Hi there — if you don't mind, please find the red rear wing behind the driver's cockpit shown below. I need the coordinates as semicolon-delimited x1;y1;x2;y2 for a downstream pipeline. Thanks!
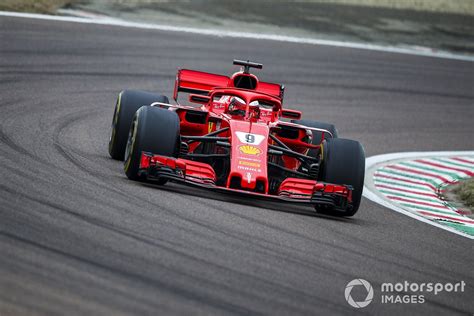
173;69;285;101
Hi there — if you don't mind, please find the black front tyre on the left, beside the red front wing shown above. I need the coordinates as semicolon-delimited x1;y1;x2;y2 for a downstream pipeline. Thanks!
124;106;179;184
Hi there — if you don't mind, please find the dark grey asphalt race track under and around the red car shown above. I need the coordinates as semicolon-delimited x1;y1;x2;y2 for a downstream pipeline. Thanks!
0;17;474;316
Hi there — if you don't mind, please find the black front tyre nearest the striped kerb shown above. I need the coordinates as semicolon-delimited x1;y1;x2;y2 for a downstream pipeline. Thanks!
316;138;365;216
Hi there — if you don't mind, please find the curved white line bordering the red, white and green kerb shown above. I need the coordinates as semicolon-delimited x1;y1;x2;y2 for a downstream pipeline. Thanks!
363;151;474;240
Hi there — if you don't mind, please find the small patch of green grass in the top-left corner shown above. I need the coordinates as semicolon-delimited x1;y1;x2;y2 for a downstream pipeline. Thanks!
0;0;76;14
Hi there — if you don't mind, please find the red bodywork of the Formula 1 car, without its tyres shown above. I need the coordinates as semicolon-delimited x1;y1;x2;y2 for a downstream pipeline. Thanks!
140;66;352;209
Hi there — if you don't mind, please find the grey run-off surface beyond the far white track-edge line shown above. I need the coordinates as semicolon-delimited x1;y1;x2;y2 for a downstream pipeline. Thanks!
73;0;474;55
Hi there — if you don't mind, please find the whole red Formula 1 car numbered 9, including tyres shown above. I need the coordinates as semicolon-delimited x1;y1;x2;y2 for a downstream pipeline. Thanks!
109;60;365;216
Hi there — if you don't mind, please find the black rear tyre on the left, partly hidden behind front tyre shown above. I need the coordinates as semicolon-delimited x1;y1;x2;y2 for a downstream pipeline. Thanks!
109;90;169;160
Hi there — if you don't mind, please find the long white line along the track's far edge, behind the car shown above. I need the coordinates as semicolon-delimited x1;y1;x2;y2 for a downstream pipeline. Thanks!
0;11;474;62
